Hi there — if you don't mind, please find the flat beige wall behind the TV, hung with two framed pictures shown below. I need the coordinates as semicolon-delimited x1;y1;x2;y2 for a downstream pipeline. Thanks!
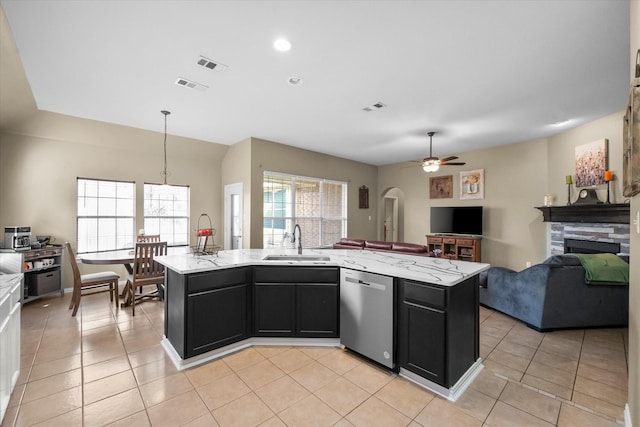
378;140;547;269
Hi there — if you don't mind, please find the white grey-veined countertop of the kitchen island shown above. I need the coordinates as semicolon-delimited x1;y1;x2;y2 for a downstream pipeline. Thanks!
157;249;490;286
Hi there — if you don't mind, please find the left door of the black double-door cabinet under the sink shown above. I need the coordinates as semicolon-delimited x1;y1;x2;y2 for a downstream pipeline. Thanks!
253;283;295;337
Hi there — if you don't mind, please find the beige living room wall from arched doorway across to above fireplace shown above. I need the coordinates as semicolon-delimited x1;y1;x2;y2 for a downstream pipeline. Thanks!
378;112;623;270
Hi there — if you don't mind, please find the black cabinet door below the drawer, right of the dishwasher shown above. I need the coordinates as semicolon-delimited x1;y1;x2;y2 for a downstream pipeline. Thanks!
399;301;447;387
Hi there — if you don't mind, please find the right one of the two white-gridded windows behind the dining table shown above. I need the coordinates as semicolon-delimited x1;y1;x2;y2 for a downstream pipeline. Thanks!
144;183;189;246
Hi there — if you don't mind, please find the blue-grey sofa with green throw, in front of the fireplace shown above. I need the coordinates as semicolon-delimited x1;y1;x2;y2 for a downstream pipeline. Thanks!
480;255;629;331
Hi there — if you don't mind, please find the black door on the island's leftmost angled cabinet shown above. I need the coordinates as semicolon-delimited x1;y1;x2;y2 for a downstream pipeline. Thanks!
186;283;249;357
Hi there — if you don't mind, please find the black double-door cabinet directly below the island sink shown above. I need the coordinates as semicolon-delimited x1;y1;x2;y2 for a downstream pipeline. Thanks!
253;267;340;338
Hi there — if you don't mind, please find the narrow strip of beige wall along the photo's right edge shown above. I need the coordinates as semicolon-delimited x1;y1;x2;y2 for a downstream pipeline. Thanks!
627;0;640;427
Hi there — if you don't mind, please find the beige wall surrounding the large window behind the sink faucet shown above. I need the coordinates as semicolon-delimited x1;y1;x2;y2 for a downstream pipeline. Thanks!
245;138;378;248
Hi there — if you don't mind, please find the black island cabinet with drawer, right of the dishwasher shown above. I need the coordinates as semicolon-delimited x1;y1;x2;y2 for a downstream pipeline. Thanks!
398;276;479;388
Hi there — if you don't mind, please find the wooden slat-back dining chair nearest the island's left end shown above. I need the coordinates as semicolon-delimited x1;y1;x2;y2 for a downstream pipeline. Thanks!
129;242;167;316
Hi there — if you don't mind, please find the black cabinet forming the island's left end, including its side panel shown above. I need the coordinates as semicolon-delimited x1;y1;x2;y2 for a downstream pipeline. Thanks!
165;267;251;359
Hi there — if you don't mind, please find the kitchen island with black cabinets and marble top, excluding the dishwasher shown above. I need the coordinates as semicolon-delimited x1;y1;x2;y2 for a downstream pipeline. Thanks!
158;249;489;400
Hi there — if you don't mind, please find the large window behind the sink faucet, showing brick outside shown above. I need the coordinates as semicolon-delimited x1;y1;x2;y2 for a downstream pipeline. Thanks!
263;172;347;248
